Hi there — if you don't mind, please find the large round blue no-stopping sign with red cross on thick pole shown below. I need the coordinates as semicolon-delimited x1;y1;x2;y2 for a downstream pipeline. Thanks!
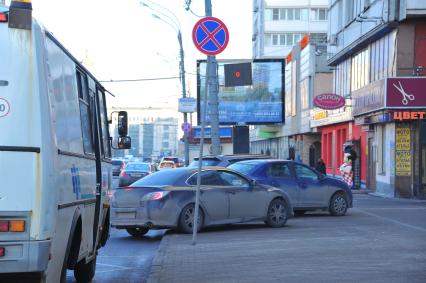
192;17;229;55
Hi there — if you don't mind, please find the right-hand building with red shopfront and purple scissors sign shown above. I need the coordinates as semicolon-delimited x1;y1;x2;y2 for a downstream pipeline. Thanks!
326;0;426;198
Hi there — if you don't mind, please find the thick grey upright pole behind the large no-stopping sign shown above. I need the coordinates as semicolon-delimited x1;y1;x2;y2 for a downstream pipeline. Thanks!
205;0;221;155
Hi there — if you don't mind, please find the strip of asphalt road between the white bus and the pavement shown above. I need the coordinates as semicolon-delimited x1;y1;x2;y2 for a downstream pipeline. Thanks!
67;229;166;283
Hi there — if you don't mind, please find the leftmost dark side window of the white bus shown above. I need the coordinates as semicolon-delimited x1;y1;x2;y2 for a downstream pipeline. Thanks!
77;70;93;154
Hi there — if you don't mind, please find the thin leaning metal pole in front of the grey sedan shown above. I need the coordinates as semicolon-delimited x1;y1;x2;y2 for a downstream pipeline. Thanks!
192;58;210;245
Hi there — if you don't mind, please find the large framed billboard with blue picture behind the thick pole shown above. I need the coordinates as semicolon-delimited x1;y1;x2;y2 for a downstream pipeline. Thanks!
197;59;285;125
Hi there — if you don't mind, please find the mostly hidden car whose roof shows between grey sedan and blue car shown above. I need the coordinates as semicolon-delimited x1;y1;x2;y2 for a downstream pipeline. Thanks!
189;154;271;167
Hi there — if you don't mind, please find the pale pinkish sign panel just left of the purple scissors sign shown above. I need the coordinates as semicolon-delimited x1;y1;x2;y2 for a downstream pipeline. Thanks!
352;80;385;116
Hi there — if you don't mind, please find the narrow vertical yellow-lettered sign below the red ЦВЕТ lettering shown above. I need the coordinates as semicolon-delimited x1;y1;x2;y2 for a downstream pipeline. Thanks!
395;127;411;176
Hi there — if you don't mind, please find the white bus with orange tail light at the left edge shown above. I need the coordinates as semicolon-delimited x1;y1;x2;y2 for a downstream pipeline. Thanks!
0;0;130;283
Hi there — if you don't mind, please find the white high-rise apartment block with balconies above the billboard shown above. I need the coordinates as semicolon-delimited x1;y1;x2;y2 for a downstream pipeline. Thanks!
252;0;328;59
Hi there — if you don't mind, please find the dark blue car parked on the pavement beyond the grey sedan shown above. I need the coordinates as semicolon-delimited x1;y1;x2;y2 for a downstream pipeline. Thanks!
229;160;352;216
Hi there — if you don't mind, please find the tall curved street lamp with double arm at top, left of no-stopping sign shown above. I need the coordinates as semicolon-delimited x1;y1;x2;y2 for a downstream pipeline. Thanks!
140;1;189;166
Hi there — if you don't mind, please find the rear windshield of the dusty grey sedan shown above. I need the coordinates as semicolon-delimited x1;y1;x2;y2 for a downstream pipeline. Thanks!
132;168;189;187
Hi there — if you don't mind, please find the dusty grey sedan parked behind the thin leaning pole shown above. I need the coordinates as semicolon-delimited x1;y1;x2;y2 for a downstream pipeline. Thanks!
111;167;293;237
